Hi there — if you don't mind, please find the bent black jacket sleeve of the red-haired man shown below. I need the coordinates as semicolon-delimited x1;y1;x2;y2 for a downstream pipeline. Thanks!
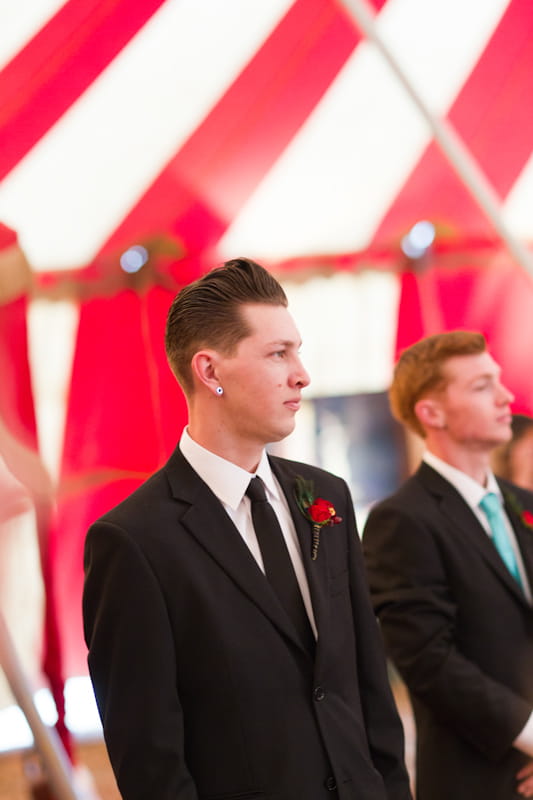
363;501;531;760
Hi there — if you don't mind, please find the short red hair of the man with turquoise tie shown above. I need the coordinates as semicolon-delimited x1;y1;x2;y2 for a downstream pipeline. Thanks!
389;331;487;436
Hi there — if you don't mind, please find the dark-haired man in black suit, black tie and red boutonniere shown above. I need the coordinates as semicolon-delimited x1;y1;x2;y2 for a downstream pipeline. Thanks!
83;259;410;800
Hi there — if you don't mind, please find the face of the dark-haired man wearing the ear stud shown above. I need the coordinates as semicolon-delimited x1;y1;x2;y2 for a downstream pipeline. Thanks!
217;303;309;447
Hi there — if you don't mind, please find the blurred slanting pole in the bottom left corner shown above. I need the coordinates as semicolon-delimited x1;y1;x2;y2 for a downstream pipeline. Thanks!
0;610;78;800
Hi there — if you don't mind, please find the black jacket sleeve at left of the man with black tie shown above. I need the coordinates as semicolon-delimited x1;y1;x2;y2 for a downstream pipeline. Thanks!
83;522;198;800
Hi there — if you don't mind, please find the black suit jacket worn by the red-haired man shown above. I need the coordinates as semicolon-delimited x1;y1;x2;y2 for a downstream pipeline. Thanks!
363;463;533;800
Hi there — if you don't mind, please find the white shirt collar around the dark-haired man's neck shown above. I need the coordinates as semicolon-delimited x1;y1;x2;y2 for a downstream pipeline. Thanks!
179;428;280;510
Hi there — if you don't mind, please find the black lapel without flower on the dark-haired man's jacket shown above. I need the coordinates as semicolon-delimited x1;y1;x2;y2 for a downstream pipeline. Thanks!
165;448;307;653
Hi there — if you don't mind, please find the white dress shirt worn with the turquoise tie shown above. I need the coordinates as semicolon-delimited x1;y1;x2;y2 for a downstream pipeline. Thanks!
422;450;533;757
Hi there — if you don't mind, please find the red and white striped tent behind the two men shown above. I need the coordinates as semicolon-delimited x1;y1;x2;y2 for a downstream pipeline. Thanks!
0;0;533;752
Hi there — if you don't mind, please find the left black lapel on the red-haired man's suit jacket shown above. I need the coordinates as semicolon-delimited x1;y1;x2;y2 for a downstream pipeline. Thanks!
416;463;527;603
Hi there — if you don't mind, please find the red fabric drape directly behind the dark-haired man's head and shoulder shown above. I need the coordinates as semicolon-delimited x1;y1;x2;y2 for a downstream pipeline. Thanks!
49;287;186;675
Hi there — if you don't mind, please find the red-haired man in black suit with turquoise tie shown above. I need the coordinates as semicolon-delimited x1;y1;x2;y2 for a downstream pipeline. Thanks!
363;331;533;800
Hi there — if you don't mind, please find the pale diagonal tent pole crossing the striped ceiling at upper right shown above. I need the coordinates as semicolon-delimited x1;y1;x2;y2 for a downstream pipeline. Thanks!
340;0;533;275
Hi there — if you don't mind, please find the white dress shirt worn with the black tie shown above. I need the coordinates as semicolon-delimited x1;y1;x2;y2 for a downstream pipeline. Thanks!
179;428;317;638
